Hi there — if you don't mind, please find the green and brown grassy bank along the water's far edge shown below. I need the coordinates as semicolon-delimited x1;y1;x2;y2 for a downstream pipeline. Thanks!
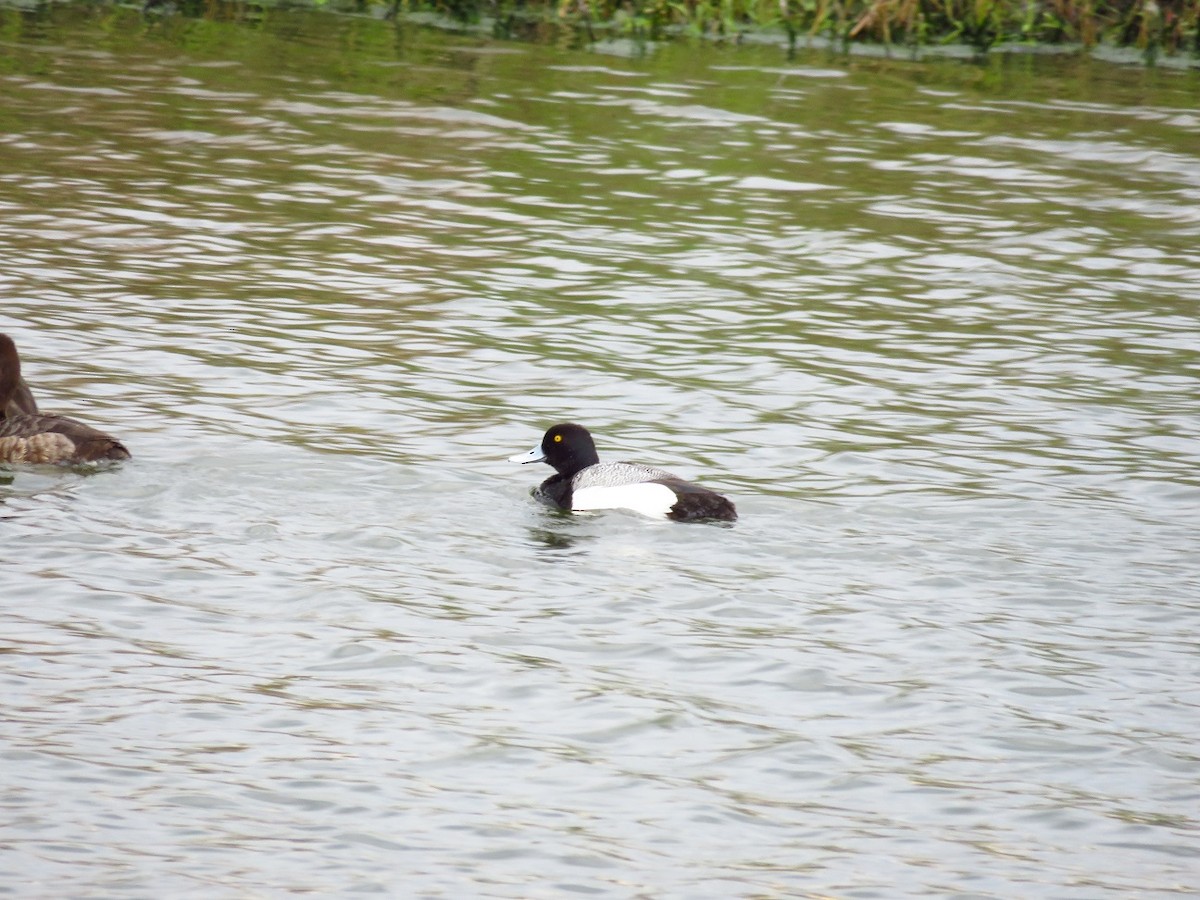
394;0;1200;58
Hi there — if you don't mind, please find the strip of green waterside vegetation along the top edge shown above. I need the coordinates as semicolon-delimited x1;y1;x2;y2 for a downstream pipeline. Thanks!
49;0;1180;62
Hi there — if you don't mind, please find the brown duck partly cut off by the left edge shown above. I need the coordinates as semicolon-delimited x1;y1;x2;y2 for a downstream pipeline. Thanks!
0;335;130;463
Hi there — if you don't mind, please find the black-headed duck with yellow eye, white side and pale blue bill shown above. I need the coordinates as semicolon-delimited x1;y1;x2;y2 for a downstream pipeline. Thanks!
509;422;738;522
